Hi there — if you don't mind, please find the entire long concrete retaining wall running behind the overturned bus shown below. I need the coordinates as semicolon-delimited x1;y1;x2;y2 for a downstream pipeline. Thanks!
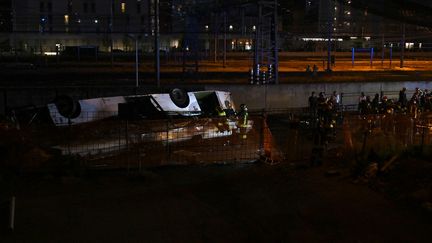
0;81;432;114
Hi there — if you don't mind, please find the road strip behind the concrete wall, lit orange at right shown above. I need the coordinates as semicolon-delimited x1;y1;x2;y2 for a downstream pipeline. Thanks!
0;58;432;87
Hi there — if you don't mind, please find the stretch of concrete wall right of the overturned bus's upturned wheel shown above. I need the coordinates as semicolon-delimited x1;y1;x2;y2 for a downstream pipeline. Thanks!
205;81;432;110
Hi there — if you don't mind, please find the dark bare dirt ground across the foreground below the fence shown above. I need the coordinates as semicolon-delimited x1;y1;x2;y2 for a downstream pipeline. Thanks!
0;159;432;243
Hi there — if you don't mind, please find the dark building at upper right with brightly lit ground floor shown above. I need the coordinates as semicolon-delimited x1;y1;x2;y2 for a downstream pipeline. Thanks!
298;0;432;50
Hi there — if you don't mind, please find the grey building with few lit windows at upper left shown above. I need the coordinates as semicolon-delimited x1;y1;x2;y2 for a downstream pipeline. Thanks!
11;0;180;53
